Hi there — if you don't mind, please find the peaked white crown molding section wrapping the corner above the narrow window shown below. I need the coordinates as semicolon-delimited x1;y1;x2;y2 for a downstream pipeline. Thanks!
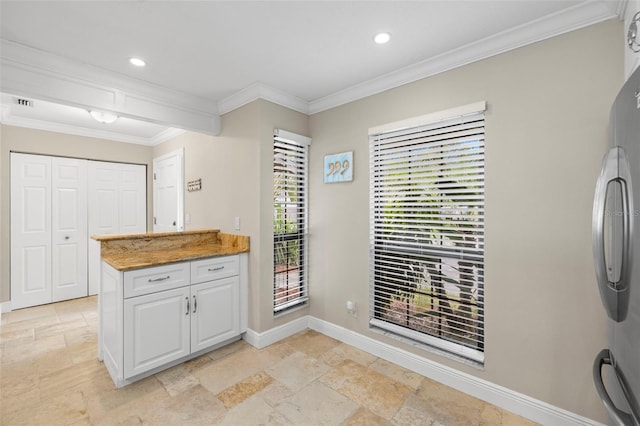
218;82;309;115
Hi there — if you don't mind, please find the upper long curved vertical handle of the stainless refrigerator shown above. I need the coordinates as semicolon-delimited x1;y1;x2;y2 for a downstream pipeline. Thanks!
593;147;635;322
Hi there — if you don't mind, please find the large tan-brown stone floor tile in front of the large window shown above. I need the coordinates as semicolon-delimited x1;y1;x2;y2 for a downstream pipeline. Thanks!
319;360;411;420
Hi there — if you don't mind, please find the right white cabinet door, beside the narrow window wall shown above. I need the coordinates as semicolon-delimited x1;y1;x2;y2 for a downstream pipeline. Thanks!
191;276;240;352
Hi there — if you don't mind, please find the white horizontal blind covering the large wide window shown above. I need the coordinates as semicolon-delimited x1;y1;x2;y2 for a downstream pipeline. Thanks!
369;104;484;363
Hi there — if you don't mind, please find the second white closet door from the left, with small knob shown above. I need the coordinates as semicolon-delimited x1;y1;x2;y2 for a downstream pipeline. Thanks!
51;157;88;302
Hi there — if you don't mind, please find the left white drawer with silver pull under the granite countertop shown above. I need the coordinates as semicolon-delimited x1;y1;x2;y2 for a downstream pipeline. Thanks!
124;262;190;299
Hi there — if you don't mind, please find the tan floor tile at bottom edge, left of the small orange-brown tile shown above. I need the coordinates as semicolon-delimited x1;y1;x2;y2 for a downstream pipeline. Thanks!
140;386;226;425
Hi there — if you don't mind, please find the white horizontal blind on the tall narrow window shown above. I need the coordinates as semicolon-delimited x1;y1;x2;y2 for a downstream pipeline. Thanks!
273;130;311;313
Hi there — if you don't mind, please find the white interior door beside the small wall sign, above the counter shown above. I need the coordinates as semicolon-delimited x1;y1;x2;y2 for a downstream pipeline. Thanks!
153;149;184;232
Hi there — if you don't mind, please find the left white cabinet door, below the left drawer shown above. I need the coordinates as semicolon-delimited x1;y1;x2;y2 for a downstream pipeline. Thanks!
124;287;190;379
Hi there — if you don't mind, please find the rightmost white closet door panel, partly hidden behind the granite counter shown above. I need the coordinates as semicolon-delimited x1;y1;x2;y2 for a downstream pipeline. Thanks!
118;164;147;234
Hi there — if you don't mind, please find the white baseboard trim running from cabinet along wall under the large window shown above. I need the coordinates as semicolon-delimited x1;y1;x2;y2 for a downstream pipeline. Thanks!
245;316;604;426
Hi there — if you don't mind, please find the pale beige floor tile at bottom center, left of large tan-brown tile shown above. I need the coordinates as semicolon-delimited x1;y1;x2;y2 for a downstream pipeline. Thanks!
276;381;358;425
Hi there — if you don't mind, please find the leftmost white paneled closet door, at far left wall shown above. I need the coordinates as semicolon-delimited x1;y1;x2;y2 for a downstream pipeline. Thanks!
11;153;51;309
